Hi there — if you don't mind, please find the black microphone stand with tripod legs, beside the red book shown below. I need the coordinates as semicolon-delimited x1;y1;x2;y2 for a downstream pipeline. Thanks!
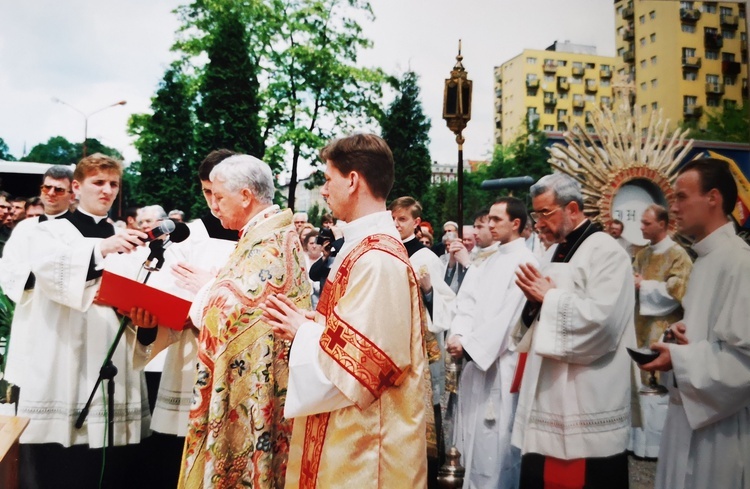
75;237;171;449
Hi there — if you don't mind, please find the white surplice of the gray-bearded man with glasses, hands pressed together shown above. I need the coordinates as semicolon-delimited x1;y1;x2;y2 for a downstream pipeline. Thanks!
512;232;635;460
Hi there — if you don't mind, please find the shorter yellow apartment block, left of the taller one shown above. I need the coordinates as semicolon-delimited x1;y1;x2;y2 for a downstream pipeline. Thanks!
495;42;617;144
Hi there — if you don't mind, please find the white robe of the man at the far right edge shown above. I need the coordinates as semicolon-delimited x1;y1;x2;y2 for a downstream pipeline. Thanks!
656;223;750;489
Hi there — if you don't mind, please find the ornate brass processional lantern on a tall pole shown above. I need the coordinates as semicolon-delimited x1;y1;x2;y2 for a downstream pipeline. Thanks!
443;40;472;237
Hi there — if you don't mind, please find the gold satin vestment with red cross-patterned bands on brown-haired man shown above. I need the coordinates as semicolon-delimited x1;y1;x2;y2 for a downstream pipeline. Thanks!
286;234;431;489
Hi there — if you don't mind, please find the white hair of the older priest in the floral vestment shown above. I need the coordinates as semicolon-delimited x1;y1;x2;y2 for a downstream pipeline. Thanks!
210;155;276;204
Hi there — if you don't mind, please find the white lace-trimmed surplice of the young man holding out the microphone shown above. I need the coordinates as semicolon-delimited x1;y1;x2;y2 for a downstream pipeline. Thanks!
6;219;150;448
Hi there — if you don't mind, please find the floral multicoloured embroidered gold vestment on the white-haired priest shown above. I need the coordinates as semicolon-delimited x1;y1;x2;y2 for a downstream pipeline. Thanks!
179;207;311;489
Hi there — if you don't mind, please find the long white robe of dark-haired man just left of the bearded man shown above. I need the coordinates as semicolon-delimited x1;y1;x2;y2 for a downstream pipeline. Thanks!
451;238;538;489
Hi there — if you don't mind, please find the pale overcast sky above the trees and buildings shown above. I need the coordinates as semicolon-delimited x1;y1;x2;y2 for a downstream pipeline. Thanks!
0;0;615;173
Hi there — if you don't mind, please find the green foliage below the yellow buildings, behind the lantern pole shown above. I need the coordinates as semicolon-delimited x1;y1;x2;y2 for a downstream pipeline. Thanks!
422;128;551;227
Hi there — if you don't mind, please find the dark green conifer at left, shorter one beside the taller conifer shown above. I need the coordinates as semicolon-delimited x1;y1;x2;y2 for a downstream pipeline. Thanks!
126;66;200;216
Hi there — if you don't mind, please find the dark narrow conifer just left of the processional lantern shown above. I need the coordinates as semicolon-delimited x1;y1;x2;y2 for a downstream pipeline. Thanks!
380;71;432;200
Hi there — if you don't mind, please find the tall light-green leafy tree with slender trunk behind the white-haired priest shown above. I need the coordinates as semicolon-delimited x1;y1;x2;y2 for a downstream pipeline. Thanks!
264;0;383;208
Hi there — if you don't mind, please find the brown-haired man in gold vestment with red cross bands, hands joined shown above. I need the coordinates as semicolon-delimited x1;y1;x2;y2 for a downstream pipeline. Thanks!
265;134;429;489
